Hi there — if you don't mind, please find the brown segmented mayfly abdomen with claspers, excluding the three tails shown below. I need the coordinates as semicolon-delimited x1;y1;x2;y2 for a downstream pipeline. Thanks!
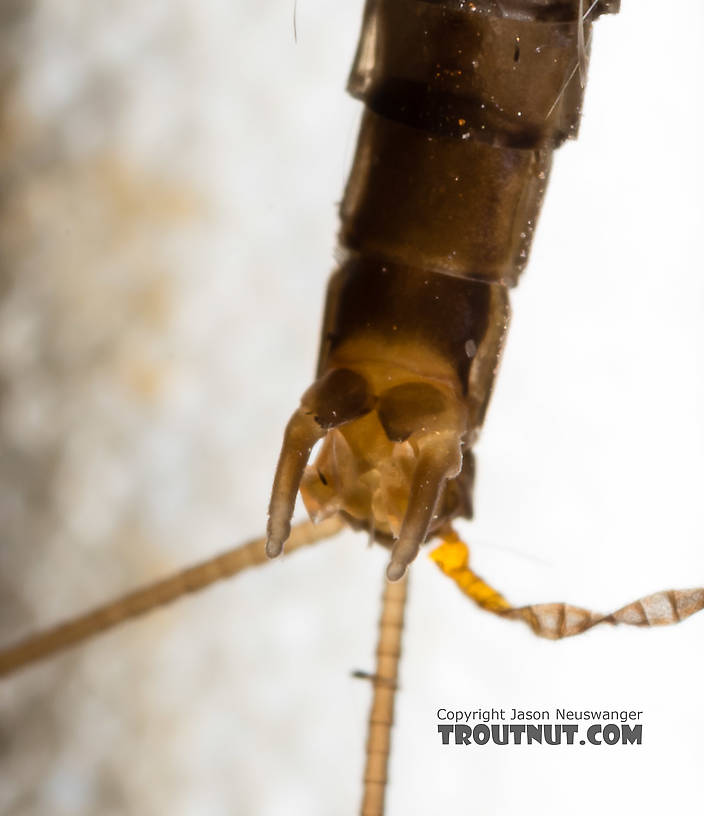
268;0;618;579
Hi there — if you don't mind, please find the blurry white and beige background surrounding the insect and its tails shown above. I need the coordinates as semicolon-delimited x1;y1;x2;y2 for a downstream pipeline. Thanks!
0;0;704;816
